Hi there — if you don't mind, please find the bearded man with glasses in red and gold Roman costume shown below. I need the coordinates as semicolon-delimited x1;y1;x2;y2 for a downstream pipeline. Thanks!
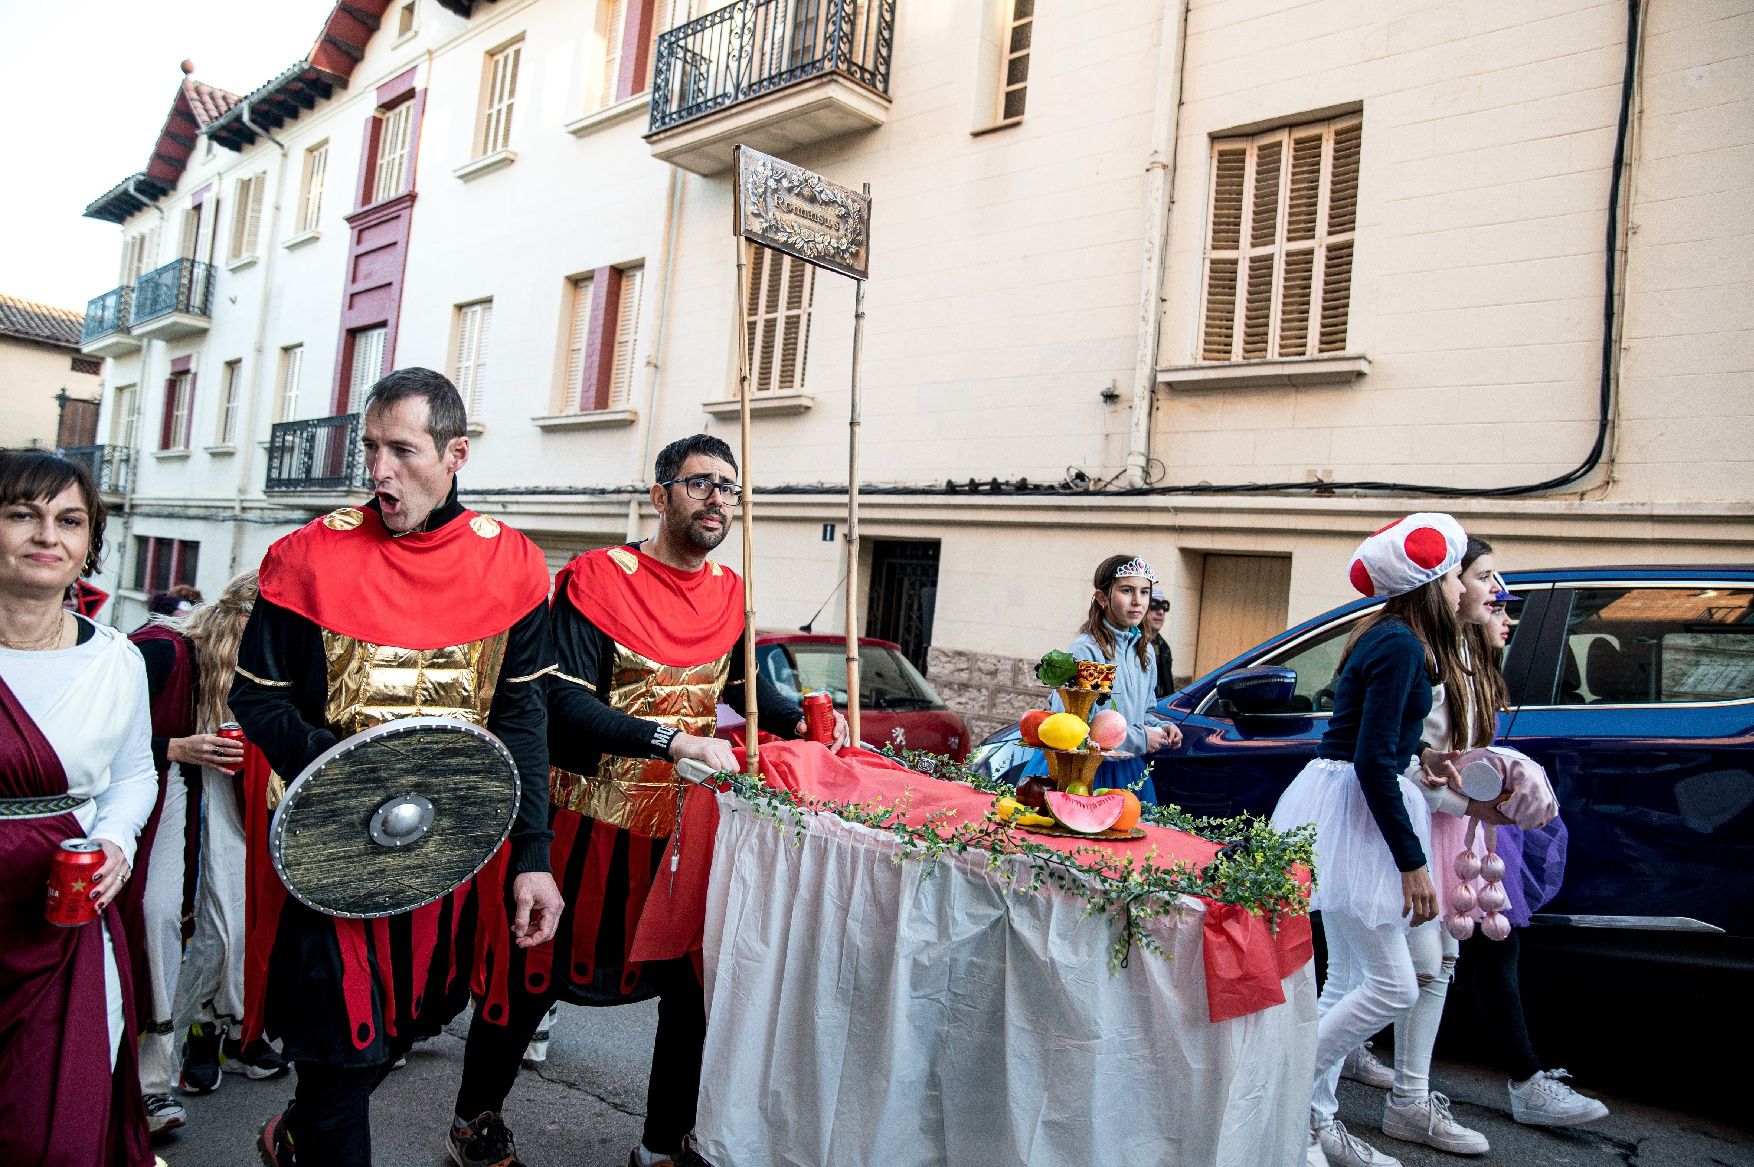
451;433;838;1167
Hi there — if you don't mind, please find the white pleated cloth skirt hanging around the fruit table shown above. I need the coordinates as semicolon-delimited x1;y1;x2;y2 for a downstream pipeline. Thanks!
696;795;1316;1167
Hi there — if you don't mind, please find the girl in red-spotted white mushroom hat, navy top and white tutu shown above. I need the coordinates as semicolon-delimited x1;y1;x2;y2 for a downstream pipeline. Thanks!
1273;512;1486;1167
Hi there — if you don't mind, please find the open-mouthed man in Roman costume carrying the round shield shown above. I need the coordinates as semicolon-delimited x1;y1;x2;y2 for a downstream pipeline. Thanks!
232;369;560;1167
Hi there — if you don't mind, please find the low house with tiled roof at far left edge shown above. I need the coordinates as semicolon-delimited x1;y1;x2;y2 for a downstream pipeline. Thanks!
0;295;103;449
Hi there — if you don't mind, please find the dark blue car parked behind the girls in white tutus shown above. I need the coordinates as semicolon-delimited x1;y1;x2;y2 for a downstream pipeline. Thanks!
975;567;1754;970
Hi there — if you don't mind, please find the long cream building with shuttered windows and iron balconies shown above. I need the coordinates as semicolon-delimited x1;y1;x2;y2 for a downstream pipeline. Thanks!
75;0;1754;728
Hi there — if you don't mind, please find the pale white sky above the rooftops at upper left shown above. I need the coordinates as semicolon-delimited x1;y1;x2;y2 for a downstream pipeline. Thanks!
0;0;333;311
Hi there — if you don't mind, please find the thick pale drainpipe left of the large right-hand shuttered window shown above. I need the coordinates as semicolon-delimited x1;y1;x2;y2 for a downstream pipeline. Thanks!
1126;0;1191;486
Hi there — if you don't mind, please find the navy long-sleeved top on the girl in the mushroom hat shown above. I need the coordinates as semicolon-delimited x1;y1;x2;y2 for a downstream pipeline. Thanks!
1316;616;1431;872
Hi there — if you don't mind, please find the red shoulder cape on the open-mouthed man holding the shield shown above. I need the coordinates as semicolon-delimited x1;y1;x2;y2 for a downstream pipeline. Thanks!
260;507;547;649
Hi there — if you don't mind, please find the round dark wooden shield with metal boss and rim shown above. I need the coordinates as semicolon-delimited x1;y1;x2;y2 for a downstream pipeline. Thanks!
268;718;517;918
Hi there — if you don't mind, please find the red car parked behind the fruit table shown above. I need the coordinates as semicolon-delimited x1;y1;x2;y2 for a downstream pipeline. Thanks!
719;632;972;762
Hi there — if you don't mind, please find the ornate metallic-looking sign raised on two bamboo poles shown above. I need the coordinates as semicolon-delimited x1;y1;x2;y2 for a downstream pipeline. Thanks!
735;146;872;279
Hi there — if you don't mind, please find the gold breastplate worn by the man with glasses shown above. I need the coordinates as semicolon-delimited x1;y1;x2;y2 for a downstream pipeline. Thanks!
549;644;731;839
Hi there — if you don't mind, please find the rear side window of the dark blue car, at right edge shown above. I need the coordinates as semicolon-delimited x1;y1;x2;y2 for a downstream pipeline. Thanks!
1558;588;1754;705
